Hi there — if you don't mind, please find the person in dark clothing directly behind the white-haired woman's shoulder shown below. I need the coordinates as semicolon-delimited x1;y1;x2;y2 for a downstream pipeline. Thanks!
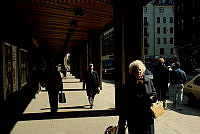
153;58;169;109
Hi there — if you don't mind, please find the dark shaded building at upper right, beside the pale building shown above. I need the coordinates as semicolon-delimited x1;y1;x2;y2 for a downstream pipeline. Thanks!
175;0;200;72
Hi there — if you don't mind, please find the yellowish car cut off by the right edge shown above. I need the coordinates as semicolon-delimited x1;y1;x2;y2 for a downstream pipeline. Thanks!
183;74;200;105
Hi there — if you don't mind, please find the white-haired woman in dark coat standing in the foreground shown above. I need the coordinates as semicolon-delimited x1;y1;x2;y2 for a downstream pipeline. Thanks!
118;60;157;134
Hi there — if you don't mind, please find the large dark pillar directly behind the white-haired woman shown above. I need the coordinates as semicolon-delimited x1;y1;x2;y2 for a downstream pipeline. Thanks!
113;0;144;111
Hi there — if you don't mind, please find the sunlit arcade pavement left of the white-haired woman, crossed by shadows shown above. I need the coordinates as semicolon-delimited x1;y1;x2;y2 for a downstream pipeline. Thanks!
11;76;118;134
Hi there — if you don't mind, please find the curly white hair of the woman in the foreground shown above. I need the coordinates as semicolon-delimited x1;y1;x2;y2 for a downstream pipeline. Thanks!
129;60;146;74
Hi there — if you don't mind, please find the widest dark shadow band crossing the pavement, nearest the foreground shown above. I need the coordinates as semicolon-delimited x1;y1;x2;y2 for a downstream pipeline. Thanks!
19;109;116;121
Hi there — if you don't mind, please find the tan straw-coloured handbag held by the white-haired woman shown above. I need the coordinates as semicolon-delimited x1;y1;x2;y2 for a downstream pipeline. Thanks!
150;101;165;119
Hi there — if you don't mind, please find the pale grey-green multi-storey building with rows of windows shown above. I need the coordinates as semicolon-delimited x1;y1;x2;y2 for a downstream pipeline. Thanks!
143;0;176;59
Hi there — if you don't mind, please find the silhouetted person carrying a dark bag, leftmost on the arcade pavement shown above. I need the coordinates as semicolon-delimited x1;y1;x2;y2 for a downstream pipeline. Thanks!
42;57;63;113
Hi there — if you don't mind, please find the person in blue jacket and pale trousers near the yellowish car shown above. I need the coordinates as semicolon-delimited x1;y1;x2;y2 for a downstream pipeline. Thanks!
170;62;187;110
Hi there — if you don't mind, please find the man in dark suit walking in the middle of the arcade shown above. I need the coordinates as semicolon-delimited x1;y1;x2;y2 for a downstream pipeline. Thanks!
83;63;100;109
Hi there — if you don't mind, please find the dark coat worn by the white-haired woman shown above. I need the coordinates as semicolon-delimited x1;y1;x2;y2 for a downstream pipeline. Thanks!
119;76;157;132
